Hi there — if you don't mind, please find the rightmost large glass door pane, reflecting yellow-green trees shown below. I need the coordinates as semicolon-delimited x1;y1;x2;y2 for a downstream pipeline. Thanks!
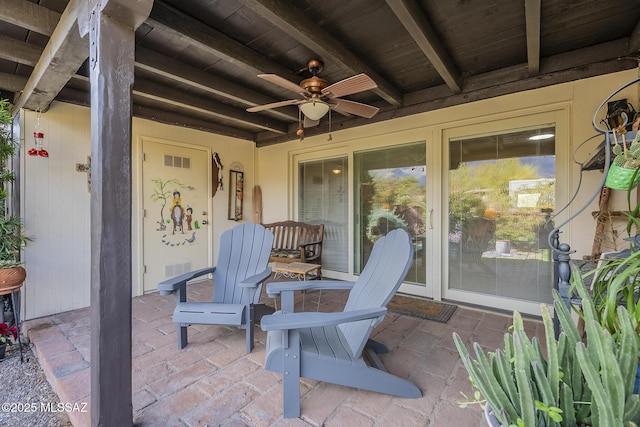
446;123;556;309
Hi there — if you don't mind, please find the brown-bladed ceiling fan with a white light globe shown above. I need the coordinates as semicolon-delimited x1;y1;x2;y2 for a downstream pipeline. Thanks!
247;59;380;127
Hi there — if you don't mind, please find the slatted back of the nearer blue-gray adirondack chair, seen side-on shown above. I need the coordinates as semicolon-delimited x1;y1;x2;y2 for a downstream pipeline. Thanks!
338;229;413;357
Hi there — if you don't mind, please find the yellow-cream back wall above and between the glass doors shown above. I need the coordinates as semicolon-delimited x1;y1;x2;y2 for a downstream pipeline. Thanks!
257;70;639;272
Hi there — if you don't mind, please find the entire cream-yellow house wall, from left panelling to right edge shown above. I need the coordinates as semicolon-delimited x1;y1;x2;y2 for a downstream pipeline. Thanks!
20;70;638;319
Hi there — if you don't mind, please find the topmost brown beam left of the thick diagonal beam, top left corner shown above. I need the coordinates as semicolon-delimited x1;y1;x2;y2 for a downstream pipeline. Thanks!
0;0;60;36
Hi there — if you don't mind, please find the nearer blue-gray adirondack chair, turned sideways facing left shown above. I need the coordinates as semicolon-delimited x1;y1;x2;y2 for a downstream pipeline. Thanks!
261;229;422;418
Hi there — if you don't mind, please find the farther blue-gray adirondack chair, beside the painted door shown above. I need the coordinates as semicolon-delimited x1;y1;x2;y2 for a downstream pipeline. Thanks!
158;223;273;353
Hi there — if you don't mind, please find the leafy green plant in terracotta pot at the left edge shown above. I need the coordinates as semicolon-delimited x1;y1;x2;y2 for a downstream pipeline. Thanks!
0;99;28;293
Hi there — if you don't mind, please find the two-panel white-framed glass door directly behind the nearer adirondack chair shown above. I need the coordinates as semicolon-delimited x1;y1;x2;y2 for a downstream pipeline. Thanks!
289;131;439;297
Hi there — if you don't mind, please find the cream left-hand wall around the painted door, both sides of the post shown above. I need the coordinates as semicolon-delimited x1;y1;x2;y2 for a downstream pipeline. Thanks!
21;102;255;319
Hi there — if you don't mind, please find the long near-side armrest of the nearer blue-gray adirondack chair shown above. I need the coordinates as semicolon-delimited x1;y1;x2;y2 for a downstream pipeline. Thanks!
260;307;387;331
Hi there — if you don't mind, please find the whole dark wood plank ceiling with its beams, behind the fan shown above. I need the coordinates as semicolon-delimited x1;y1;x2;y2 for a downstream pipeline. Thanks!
0;0;640;147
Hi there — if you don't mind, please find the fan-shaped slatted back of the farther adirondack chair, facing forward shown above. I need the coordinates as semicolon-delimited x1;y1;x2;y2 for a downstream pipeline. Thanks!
213;223;273;304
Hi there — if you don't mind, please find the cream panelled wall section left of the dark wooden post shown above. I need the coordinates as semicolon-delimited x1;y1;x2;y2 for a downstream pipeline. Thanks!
21;103;91;319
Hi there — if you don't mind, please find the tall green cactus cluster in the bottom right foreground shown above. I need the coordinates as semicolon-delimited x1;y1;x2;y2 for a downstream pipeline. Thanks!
453;272;640;427
